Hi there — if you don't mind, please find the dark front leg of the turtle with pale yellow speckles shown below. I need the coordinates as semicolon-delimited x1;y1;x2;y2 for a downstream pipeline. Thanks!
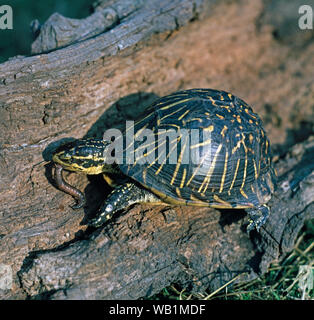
89;183;162;227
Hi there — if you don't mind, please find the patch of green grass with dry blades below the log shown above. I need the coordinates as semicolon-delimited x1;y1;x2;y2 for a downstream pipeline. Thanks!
151;221;314;300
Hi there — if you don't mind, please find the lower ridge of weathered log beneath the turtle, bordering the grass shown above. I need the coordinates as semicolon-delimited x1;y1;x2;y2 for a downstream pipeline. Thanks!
19;136;314;299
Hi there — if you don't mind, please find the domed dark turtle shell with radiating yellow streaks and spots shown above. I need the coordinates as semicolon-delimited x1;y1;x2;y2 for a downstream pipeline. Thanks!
120;89;275;208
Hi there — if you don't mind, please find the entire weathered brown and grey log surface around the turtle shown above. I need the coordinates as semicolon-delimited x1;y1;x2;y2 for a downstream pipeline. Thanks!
0;0;314;299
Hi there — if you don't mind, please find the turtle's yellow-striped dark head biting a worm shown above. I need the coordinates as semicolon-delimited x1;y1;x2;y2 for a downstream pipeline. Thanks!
52;139;110;174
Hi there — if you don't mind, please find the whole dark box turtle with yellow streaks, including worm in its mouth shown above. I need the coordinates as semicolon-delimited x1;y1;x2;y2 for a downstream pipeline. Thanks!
53;89;276;231
